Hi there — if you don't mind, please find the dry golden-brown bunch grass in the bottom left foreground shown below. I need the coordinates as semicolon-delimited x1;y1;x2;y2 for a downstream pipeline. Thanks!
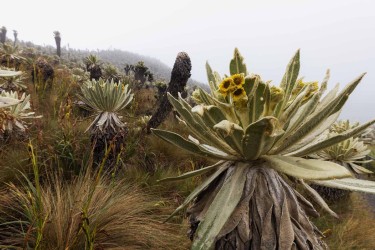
0;168;189;249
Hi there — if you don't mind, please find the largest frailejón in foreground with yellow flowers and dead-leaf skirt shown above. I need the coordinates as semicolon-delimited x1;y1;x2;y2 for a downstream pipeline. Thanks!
153;49;375;250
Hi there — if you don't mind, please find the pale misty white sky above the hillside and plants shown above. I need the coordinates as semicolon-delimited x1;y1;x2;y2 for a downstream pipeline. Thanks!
0;0;375;122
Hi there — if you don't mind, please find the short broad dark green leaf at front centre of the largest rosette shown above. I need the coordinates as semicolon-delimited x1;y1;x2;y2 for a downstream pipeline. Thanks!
242;116;277;160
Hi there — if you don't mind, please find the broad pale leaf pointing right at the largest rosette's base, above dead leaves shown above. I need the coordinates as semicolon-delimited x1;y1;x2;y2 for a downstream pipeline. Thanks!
261;155;351;180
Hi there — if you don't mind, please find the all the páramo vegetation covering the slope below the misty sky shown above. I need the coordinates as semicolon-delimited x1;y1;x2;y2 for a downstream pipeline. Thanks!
0;27;375;249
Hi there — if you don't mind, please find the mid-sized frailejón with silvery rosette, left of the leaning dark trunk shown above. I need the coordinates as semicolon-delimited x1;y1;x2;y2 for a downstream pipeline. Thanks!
79;79;133;168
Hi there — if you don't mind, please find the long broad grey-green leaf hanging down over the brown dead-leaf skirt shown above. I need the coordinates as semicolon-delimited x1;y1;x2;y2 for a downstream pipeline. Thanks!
191;163;248;250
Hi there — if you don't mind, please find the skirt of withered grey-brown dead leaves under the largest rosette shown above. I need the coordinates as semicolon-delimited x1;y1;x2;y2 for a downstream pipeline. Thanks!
188;165;327;250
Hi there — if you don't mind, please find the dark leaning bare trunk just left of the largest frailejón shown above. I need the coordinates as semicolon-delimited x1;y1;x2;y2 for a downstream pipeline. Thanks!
147;52;191;133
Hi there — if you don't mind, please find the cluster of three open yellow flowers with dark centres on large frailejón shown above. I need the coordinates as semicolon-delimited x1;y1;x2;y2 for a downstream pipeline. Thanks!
219;74;247;102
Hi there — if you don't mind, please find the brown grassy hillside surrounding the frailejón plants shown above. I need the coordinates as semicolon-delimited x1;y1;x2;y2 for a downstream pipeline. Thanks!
0;34;375;250
